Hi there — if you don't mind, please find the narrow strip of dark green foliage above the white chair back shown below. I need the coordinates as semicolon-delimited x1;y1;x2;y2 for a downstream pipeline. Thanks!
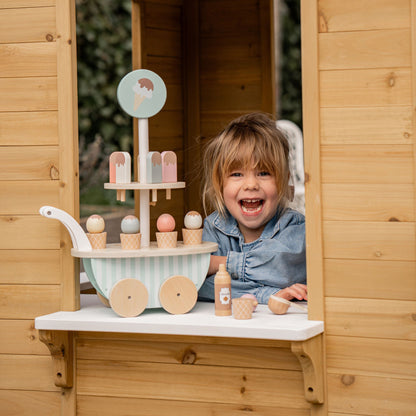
279;0;302;127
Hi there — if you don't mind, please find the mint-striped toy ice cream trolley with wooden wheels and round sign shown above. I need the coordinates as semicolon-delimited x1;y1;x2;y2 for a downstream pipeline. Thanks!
40;70;217;317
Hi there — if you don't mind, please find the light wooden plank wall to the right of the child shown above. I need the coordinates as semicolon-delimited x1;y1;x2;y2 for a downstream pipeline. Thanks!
302;0;416;416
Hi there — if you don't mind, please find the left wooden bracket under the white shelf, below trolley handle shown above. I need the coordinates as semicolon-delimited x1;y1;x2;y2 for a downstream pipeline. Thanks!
39;329;73;388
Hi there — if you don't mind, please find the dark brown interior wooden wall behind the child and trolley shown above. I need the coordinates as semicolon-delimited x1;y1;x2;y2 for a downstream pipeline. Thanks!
132;0;275;223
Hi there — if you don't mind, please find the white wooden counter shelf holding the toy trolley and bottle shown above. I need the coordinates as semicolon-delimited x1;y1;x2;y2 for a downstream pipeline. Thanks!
35;295;324;341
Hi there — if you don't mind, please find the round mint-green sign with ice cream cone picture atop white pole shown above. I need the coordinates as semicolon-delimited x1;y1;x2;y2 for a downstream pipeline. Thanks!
117;69;166;118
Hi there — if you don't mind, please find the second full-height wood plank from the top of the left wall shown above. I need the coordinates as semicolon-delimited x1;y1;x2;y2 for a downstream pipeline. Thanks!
0;42;56;78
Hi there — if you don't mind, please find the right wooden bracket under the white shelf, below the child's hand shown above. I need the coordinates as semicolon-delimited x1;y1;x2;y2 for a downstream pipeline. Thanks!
291;334;325;404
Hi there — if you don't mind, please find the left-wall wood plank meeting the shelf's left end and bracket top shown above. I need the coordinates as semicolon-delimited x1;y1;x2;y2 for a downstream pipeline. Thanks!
0;319;49;355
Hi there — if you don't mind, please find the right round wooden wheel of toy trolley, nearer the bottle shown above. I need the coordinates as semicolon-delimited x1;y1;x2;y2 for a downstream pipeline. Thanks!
159;276;198;315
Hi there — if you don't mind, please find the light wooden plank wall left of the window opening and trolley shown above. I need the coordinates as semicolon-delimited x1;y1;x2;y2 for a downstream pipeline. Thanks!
0;0;79;416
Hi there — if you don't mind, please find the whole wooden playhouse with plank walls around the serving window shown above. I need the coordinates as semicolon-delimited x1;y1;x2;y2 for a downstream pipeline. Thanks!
0;0;416;416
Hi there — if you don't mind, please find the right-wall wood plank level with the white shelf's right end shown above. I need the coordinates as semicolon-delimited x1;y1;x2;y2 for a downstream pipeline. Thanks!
325;297;416;341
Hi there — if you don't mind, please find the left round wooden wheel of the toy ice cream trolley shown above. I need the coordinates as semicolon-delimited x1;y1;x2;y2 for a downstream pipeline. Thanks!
110;279;149;318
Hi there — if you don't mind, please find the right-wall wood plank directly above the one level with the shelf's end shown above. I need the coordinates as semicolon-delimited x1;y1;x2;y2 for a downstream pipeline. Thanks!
324;259;416;300
